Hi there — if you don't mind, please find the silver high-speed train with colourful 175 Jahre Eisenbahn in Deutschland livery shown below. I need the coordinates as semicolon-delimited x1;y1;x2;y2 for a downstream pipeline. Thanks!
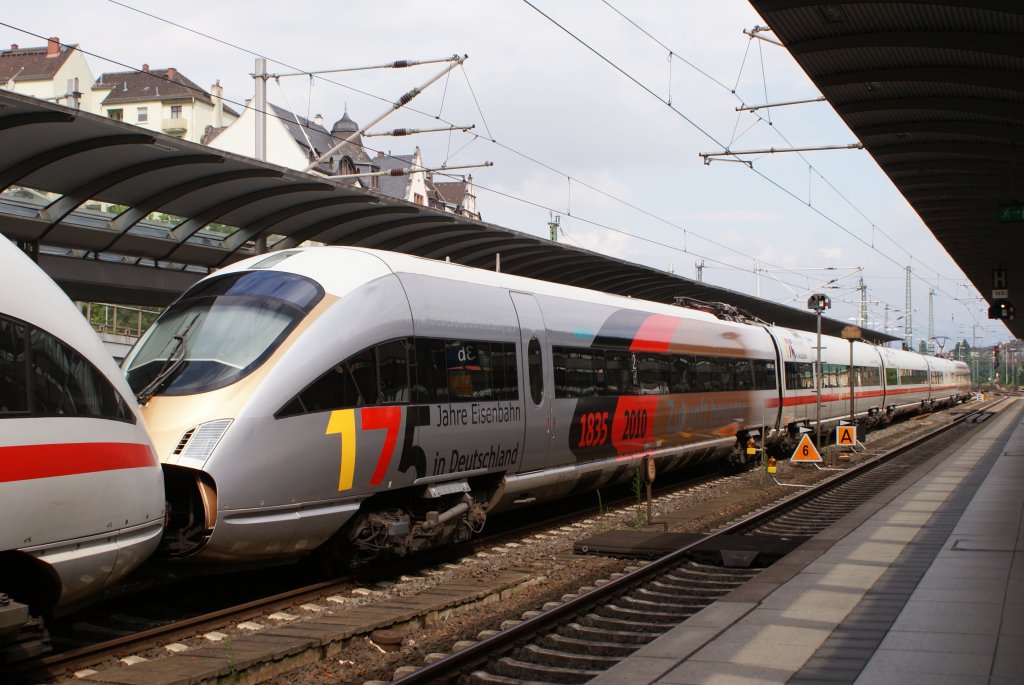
123;248;970;563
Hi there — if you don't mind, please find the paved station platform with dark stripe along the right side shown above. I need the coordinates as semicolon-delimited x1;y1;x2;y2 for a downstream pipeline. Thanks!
591;398;1024;685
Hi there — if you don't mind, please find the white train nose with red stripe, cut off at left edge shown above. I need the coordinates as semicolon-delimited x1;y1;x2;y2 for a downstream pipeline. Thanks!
0;237;164;652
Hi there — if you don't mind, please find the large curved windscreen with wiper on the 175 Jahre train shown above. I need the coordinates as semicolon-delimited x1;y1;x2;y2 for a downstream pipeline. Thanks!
124;271;324;395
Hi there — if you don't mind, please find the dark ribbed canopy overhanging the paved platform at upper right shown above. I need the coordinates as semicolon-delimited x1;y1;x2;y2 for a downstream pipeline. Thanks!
751;0;1024;338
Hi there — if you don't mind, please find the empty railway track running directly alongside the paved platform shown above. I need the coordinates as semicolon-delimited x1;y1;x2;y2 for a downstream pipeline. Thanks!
393;406;1003;685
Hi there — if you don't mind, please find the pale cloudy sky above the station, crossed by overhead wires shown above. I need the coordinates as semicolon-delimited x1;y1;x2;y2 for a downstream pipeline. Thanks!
0;0;1012;350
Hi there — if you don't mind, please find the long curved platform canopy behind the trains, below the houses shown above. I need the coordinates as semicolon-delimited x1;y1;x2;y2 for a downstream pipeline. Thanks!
0;90;896;341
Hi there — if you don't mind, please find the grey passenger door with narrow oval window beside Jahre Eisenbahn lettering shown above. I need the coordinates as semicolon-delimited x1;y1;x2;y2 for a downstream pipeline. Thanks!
509;292;556;473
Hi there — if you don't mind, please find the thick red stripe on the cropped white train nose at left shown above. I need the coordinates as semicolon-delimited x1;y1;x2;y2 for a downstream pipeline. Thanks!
0;442;158;482
